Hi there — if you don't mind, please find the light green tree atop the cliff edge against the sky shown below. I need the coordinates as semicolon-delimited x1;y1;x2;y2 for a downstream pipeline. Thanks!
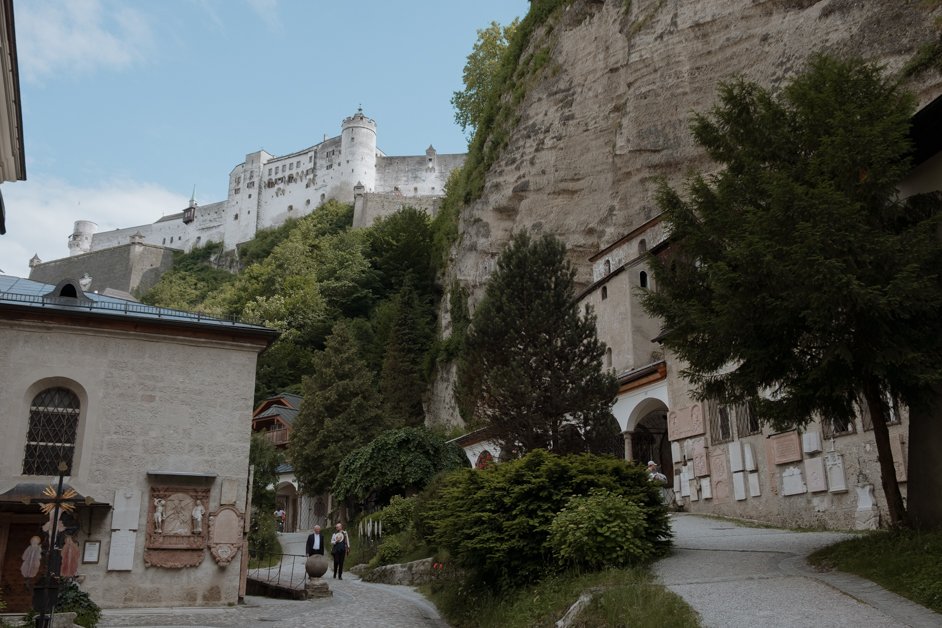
451;19;520;134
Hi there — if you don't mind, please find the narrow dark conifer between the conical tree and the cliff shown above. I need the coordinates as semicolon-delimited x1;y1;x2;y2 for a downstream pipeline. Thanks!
380;282;435;427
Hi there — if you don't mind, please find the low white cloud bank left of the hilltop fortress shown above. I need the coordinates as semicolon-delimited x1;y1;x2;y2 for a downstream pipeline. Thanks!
0;177;188;277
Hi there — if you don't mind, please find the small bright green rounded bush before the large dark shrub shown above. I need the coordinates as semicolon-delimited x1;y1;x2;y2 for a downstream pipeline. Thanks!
549;489;653;570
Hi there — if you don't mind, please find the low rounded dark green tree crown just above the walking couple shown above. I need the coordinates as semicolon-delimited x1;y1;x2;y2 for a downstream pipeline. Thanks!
333;427;468;506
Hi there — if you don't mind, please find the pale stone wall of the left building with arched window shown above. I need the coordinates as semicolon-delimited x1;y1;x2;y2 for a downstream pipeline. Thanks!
0;323;256;608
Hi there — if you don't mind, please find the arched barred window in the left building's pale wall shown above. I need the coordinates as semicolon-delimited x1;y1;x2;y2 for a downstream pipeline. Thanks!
23;387;81;475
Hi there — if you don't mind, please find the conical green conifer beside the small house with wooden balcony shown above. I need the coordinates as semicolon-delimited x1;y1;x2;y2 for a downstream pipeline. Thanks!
288;321;383;495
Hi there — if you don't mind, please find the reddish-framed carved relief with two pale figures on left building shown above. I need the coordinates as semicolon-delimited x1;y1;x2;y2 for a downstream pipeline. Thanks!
144;486;209;569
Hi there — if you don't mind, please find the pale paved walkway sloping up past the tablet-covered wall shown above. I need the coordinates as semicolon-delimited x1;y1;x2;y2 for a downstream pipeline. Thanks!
655;514;942;628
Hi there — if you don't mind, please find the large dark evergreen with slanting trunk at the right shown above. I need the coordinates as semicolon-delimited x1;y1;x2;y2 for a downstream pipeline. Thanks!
644;56;942;524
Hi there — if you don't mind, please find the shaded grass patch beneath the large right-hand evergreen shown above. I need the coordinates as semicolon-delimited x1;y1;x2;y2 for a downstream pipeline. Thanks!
809;530;942;613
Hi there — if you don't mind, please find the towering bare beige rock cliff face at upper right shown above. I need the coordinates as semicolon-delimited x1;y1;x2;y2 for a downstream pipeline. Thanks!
429;0;942;422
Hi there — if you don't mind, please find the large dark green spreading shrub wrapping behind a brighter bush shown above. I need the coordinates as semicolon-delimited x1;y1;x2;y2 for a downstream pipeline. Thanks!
416;450;670;590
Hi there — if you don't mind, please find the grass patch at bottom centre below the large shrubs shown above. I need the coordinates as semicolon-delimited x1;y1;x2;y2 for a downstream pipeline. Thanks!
423;567;700;628
